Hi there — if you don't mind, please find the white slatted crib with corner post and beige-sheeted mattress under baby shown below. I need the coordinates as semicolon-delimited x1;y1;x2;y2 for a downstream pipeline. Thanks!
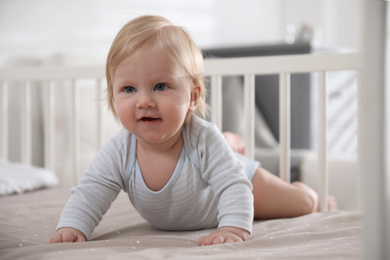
0;6;389;259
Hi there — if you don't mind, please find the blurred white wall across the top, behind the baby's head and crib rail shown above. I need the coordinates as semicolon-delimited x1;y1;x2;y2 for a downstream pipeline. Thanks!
0;0;359;66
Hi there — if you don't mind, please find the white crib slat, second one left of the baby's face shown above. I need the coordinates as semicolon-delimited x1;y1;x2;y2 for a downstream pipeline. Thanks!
71;79;80;185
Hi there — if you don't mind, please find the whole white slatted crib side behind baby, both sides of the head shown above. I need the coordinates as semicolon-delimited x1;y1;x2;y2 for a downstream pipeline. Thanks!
0;53;360;210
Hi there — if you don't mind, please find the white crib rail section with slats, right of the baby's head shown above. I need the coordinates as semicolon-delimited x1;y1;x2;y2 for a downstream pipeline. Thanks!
205;52;360;211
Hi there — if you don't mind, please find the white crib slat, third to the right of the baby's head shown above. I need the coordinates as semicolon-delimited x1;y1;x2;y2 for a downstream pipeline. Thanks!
279;73;291;182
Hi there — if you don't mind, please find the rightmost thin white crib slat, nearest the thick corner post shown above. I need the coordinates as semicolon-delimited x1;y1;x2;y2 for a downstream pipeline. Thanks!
317;71;329;212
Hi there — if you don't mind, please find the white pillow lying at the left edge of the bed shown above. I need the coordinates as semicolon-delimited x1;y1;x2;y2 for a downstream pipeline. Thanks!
0;159;58;196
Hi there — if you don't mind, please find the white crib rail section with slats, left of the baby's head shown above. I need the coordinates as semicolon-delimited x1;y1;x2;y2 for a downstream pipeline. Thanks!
0;66;105;180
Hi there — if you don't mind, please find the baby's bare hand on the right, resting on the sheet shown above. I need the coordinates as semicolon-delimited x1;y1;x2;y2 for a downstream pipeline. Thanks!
199;227;249;246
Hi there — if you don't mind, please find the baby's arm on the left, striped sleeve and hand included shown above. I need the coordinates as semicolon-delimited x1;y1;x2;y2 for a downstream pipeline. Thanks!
47;132;124;243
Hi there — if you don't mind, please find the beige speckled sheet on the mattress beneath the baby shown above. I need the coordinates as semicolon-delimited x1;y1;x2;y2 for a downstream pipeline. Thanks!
0;187;362;260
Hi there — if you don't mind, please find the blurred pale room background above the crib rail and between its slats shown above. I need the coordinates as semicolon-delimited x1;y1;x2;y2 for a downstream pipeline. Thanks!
0;0;363;209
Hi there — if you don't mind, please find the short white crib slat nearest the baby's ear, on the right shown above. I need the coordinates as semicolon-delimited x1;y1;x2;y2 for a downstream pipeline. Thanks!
211;75;222;130
